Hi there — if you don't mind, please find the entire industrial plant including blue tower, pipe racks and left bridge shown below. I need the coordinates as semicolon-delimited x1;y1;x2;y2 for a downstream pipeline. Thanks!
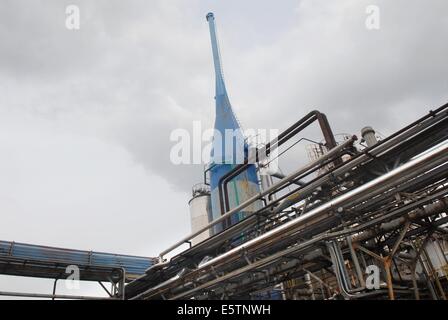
0;13;448;300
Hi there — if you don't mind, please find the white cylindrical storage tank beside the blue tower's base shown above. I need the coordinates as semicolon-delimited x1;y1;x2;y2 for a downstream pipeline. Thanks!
188;183;211;245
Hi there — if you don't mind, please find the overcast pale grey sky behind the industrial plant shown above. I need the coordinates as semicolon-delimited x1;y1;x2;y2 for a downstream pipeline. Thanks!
0;0;448;298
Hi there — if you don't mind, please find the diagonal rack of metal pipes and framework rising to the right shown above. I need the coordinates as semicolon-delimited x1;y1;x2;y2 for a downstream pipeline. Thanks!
125;104;448;300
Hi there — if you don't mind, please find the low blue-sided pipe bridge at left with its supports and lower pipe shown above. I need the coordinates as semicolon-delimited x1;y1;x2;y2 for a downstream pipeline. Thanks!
0;241;157;300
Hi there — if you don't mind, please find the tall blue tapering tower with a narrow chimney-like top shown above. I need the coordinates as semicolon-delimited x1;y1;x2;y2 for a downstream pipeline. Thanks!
207;13;259;234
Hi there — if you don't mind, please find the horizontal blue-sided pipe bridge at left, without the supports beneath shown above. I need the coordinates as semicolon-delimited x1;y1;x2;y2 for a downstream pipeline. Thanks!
0;241;157;281
